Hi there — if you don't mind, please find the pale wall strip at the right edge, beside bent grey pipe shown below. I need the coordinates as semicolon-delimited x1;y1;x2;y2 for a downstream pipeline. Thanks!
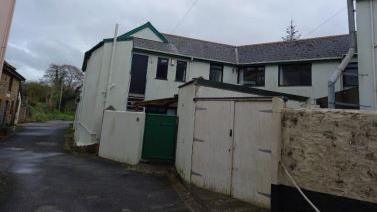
356;0;377;110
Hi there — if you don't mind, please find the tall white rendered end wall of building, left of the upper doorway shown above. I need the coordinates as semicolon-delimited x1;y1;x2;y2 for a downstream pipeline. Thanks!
75;41;132;146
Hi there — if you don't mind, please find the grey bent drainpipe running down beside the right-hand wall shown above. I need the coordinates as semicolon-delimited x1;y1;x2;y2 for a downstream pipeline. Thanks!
328;0;357;108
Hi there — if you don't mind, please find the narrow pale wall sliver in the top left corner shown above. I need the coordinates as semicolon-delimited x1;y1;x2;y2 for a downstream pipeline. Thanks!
0;0;16;76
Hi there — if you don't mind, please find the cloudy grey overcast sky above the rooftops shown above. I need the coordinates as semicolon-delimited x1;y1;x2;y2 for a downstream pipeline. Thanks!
6;0;348;80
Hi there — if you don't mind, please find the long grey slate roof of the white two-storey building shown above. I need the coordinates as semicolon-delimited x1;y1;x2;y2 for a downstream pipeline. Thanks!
134;34;350;64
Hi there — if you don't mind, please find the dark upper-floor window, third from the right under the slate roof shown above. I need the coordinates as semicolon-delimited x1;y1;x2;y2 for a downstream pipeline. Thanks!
241;66;265;86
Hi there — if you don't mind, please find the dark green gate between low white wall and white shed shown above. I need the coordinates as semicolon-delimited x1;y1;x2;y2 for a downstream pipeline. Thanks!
142;114;177;161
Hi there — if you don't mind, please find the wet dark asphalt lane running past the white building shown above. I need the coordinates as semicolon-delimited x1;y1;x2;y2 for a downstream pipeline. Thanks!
0;121;188;212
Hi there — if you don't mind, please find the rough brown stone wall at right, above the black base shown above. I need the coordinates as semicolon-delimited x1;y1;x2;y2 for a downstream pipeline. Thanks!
279;109;377;203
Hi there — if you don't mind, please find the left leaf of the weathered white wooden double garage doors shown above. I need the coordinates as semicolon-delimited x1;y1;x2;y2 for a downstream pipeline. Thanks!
191;101;234;194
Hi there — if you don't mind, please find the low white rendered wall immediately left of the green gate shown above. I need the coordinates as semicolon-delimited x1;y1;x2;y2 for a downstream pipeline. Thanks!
98;111;145;165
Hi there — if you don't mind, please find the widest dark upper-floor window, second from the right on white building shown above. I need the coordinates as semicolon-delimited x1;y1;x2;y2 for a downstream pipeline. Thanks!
279;63;312;86
